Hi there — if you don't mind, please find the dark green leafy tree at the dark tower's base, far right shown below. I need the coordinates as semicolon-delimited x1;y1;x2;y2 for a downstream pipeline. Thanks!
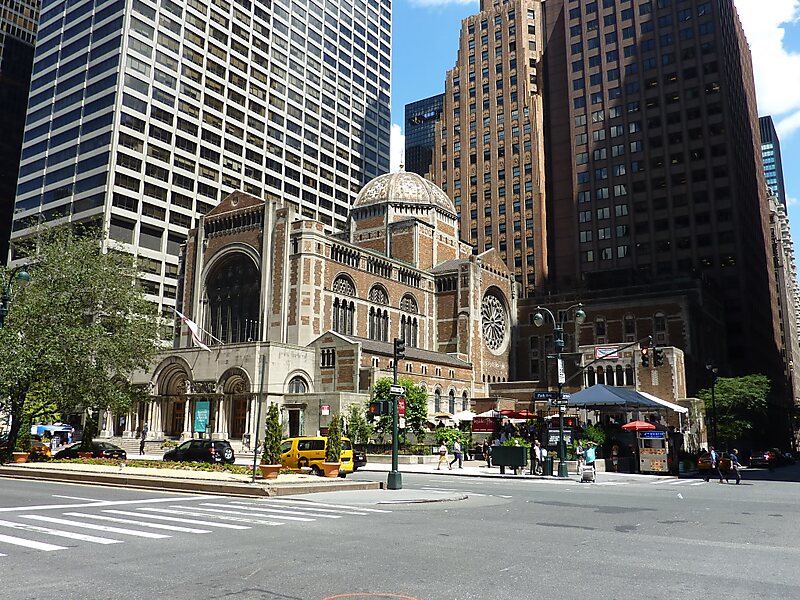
697;375;770;443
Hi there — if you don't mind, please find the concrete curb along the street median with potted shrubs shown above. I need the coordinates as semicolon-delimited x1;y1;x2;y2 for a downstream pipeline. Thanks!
0;466;383;497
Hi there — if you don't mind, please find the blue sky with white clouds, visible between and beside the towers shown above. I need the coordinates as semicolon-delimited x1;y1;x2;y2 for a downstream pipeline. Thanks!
392;0;800;231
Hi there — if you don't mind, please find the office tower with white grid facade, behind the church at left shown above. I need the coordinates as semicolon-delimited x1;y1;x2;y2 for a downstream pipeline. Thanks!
12;0;391;324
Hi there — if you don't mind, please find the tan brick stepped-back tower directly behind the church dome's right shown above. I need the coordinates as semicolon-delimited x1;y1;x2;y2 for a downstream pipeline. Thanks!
432;0;547;294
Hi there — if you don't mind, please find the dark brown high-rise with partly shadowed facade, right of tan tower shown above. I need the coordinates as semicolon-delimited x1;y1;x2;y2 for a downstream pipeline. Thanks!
544;0;782;382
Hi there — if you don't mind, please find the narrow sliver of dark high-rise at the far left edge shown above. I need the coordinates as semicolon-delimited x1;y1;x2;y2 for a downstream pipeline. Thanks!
0;0;39;262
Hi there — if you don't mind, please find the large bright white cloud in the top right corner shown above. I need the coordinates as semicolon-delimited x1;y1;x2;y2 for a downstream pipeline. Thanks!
735;0;800;123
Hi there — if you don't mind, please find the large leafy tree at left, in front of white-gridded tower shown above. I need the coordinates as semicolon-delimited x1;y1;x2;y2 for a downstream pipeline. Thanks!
0;226;160;460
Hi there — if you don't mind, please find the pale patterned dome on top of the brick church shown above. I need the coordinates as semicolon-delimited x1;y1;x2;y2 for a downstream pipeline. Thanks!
353;171;457;216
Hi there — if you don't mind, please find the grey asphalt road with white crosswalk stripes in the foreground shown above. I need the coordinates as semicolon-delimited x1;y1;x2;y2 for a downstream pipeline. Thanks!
0;465;800;600
